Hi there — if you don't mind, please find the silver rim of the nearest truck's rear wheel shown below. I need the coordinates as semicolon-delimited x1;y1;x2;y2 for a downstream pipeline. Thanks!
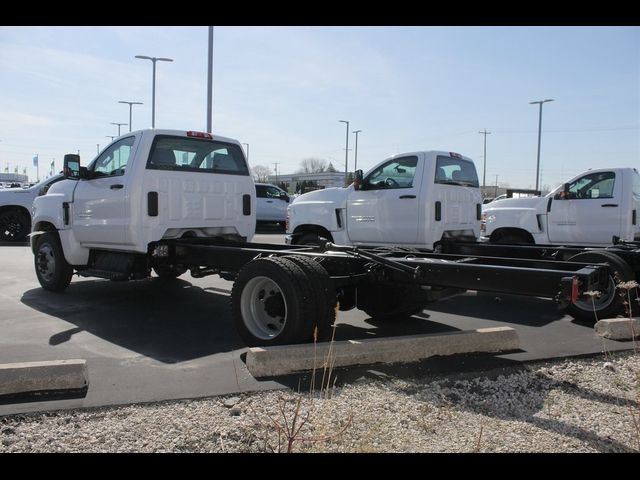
240;277;287;340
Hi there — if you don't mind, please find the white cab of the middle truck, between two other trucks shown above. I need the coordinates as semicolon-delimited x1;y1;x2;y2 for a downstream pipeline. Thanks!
286;151;482;249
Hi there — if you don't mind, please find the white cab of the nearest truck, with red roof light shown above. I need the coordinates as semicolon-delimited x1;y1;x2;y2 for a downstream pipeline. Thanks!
31;129;256;286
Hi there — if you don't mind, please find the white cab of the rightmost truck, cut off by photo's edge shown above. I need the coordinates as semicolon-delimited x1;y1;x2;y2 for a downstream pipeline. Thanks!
482;168;640;246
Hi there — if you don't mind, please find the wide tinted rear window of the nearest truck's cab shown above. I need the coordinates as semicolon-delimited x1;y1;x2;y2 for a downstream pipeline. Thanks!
147;135;249;176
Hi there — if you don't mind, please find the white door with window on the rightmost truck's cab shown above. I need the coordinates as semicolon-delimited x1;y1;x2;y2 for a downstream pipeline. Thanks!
548;172;622;245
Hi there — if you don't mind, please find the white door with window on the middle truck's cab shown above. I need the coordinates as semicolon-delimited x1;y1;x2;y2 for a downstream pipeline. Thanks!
347;156;424;245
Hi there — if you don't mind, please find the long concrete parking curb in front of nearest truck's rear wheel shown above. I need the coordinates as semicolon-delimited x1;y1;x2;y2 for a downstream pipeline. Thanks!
247;327;520;377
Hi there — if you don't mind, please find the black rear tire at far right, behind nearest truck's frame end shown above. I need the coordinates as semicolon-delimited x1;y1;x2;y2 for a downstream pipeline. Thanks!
565;251;636;322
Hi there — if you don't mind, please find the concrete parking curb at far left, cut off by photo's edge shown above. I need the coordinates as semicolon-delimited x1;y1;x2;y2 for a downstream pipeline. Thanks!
0;359;89;396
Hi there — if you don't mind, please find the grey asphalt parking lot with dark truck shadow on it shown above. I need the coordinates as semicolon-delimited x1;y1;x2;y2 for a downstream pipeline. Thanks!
0;230;633;415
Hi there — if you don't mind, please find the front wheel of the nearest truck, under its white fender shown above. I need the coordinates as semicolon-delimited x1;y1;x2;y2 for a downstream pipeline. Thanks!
33;232;73;292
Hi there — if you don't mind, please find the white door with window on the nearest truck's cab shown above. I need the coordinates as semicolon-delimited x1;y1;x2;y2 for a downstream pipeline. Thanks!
72;136;136;245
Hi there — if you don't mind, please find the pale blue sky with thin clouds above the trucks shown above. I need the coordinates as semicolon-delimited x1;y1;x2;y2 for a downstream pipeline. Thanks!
0;26;640;188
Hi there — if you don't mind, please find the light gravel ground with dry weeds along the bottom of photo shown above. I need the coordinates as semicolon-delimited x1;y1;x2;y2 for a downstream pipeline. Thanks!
0;352;640;453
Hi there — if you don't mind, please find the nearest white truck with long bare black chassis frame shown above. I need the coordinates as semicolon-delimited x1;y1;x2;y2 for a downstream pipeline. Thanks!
31;130;610;345
